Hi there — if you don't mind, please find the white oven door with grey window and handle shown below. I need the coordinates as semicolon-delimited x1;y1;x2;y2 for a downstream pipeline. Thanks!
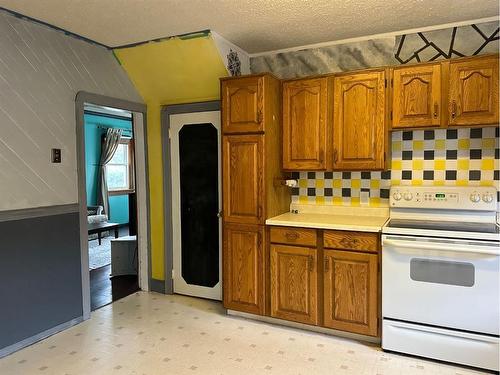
382;235;500;335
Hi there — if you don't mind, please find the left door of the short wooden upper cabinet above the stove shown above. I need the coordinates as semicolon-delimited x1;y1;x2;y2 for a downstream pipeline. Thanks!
392;63;441;129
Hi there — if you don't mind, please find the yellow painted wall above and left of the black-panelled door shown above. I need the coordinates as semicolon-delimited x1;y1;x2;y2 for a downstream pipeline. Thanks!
114;36;227;280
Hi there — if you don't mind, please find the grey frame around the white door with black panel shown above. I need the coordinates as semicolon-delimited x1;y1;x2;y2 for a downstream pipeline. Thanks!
161;100;221;294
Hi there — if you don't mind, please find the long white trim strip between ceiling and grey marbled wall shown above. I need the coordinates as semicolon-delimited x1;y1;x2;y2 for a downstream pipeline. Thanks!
248;16;500;58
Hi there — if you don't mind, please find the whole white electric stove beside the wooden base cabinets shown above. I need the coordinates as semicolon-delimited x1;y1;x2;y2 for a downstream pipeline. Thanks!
382;187;500;371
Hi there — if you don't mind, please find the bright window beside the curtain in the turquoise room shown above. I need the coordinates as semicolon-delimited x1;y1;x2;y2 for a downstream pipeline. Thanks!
106;139;134;194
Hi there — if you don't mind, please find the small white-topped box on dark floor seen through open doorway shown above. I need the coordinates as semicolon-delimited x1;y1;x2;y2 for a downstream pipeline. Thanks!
111;236;137;277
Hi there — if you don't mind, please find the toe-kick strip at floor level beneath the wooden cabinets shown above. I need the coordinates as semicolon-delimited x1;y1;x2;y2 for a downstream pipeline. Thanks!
227;310;380;344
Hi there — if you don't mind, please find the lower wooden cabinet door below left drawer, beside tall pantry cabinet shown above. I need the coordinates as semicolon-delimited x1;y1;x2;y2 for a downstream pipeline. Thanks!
271;245;318;325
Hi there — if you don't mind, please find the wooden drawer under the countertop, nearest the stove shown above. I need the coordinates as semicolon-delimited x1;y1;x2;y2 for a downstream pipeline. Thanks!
324;230;379;253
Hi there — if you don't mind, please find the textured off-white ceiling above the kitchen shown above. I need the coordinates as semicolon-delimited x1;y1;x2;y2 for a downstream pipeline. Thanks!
0;0;499;53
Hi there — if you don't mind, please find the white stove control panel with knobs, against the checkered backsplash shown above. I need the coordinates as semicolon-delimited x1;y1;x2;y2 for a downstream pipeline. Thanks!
389;186;497;211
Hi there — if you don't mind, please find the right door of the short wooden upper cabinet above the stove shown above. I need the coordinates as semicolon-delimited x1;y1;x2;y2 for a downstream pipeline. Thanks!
449;56;499;125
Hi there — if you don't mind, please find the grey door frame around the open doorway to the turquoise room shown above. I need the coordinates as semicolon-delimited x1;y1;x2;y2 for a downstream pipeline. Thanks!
75;91;151;320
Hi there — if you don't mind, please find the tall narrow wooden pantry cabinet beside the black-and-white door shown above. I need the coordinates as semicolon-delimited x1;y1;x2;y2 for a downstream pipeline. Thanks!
221;74;290;314
